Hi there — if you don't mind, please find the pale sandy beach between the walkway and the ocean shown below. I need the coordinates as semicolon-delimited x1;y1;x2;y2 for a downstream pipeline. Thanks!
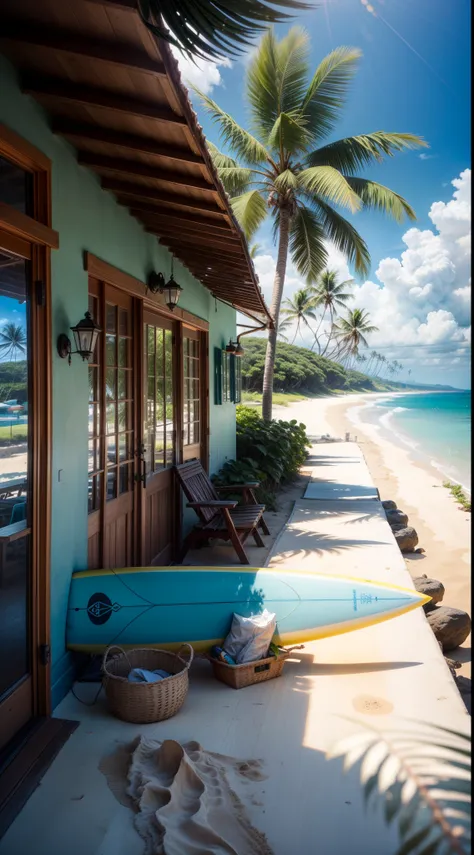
274;394;471;678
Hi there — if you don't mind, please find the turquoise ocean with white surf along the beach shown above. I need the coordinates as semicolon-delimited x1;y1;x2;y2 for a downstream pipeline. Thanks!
353;391;471;492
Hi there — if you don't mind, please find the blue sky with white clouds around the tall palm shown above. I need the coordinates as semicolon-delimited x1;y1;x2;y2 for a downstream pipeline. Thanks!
174;0;471;388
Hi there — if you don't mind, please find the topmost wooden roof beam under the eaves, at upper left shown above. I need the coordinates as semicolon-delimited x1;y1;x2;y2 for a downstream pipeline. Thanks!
0;19;166;77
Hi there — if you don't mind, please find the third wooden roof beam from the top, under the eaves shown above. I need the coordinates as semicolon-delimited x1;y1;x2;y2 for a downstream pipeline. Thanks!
52;121;203;166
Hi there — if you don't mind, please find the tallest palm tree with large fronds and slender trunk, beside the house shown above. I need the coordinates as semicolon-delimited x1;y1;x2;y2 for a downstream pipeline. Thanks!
195;27;425;420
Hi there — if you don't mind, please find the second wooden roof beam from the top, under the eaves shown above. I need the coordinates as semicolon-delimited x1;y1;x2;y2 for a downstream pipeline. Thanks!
22;74;187;128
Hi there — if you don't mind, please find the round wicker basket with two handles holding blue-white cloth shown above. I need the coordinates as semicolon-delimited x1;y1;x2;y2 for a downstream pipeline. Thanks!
102;644;194;724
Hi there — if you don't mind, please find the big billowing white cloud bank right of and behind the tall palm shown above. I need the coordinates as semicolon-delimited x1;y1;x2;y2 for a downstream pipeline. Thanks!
250;169;471;382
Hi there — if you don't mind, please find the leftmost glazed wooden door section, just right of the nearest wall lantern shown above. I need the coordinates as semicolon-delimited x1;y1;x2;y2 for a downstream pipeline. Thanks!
88;279;137;569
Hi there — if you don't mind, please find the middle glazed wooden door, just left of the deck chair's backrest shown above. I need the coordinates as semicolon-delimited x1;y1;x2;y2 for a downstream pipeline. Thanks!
141;311;180;566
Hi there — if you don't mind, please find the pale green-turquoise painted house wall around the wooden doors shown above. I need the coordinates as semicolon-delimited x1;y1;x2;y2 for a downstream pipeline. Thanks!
0;56;236;705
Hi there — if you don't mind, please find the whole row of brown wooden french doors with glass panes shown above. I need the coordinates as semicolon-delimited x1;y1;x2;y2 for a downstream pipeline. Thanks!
89;278;207;569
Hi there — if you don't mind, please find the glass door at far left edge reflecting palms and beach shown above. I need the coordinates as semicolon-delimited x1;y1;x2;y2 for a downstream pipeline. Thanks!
0;237;34;749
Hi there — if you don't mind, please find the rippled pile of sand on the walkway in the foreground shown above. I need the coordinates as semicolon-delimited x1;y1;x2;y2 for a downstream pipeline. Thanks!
99;736;272;855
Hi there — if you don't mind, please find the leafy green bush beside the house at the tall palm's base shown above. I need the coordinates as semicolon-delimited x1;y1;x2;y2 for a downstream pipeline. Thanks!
213;406;310;508
